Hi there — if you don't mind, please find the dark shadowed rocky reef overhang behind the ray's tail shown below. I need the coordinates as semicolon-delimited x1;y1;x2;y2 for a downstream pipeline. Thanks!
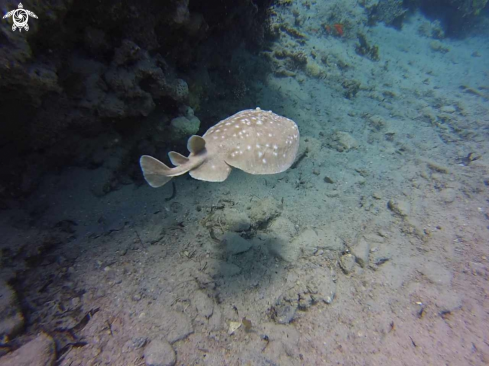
0;0;271;200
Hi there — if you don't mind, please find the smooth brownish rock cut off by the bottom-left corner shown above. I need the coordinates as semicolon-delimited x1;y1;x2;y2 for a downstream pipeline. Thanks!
0;333;56;366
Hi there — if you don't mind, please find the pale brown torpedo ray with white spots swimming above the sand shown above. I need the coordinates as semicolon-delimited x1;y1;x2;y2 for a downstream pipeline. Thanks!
139;108;299;188
